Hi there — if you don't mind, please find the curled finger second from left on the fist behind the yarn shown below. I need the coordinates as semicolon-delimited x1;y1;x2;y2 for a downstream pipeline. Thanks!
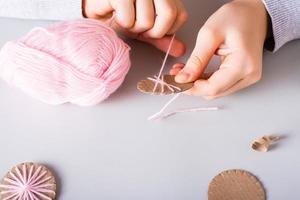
112;0;135;29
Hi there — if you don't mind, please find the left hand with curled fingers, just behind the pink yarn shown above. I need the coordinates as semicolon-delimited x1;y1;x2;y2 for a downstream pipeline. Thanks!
83;0;187;56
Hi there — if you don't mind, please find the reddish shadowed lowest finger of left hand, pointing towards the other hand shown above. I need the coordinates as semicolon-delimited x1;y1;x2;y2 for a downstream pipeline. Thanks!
137;35;186;57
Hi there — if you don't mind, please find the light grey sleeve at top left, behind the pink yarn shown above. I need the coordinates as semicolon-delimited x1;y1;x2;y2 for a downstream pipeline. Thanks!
0;0;82;20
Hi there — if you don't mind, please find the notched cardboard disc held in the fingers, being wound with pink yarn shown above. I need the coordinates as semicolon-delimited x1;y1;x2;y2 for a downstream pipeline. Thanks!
137;75;194;95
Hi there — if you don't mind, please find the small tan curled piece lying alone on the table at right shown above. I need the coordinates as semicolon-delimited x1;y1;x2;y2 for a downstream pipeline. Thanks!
251;136;281;152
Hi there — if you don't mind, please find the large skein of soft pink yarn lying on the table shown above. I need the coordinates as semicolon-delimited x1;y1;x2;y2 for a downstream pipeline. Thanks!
0;19;130;106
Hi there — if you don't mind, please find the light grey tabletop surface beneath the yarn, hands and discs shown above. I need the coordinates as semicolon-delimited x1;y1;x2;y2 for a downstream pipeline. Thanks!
0;0;300;200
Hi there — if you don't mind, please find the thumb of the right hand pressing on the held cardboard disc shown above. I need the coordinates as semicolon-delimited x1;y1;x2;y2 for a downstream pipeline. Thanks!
175;29;222;83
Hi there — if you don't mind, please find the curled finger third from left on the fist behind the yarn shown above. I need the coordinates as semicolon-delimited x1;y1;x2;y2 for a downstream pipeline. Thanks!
130;0;155;33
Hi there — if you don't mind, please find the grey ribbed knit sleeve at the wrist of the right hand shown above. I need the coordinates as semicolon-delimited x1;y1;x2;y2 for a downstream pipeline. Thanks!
264;0;300;51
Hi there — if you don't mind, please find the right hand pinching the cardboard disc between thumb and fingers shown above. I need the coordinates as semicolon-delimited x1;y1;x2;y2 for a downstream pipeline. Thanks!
170;0;268;99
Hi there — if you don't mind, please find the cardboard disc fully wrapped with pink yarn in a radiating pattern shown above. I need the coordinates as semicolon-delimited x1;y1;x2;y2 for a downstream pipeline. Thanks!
0;163;56;200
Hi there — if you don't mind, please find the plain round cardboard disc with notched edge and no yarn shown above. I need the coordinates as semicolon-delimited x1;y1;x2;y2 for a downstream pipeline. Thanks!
208;169;266;200
